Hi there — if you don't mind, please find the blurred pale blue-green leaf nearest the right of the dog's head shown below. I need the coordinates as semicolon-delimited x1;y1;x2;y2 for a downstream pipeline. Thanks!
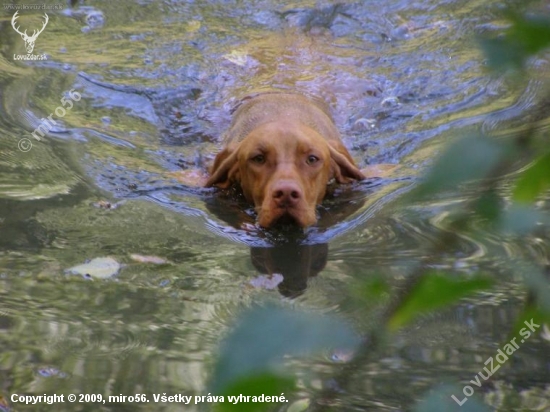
413;135;506;197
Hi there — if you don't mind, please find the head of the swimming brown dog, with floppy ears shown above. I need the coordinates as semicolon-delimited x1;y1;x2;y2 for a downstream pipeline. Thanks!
206;121;364;228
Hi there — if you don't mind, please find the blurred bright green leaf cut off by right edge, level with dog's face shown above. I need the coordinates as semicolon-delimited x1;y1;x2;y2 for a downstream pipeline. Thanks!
513;152;550;202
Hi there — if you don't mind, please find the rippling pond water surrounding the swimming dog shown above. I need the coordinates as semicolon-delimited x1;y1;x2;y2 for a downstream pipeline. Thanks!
0;0;550;411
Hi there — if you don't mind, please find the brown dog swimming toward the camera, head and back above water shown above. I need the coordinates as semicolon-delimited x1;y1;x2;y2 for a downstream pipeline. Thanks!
205;93;365;228
